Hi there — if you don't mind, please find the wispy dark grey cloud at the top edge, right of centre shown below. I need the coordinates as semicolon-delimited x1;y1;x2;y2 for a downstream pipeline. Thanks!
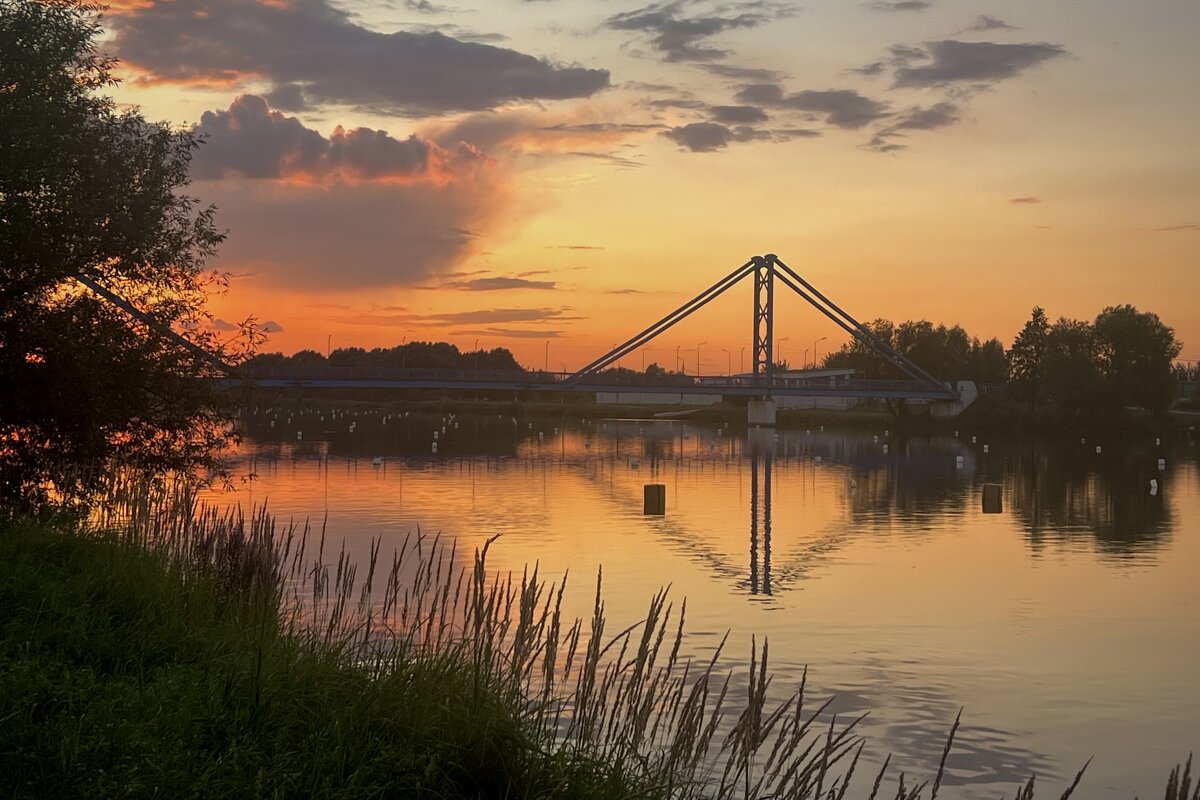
605;0;791;61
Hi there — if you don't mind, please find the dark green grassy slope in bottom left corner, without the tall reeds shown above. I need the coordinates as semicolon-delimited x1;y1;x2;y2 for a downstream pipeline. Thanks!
0;521;648;798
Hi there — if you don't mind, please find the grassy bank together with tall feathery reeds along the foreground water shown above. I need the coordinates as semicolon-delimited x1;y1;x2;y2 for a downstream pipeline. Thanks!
0;491;1200;800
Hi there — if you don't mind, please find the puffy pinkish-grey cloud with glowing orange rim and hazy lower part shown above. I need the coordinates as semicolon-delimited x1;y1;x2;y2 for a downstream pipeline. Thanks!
193;96;510;288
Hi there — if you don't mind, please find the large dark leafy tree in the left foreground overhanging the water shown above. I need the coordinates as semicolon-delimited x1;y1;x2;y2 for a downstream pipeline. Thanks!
0;0;248;506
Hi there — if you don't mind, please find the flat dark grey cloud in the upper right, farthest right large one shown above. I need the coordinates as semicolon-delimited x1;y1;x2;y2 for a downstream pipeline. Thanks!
894;40;1067;88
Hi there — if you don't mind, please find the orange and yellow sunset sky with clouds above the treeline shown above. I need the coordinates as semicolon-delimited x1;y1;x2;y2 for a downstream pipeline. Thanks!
102;0;1200;374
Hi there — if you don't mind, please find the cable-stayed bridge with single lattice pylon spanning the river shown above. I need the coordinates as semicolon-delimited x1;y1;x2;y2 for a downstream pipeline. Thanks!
80;253;973;425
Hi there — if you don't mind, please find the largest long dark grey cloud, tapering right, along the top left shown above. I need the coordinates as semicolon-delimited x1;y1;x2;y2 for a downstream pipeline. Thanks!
108;0;608;114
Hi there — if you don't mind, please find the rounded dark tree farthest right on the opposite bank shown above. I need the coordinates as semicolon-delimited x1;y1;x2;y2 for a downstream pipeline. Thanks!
1092;305;1182;414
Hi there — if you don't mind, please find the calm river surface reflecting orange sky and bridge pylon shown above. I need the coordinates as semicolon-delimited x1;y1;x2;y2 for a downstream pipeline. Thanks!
204;409;1200;798
